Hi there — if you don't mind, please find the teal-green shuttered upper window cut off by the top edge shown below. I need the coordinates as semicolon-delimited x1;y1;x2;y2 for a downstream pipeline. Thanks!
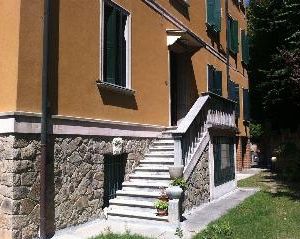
206;0;221;32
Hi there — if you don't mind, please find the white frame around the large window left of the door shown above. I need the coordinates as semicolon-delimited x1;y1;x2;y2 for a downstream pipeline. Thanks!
99;0;132;89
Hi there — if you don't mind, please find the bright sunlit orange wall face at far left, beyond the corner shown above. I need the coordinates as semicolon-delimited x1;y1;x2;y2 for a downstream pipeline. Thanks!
0;0;20;112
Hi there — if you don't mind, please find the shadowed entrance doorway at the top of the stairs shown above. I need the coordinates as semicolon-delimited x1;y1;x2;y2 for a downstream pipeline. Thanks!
170;50;199;126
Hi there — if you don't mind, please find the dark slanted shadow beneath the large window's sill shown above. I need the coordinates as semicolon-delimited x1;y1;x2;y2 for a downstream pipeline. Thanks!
98;87;138;110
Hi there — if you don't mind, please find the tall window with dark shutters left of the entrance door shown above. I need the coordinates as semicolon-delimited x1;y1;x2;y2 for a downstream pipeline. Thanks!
102;0;130;88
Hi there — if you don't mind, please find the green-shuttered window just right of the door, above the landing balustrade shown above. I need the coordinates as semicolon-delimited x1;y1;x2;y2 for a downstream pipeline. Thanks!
207;65;222;96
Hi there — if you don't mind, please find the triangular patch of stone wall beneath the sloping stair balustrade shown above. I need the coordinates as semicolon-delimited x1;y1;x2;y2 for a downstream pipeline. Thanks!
182;145;210;211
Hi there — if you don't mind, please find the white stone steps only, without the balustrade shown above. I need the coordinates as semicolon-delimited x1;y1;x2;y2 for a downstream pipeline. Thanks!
108;137;174;222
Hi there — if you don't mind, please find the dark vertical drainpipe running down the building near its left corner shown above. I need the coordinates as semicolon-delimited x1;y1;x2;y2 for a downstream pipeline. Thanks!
40;0;50;239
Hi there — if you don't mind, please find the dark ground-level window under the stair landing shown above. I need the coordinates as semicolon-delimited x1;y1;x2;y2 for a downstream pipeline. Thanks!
213;137;235;186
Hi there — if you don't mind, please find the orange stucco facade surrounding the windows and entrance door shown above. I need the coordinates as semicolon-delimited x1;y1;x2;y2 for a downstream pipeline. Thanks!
0;0;248;134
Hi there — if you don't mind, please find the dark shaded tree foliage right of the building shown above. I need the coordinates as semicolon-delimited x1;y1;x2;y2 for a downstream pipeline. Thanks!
248;0;300;128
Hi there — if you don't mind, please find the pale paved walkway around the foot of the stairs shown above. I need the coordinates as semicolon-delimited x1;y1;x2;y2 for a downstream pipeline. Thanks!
53;188;257;239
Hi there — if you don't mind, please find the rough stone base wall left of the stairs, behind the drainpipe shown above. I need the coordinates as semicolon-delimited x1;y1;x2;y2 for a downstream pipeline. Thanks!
0;134;152;239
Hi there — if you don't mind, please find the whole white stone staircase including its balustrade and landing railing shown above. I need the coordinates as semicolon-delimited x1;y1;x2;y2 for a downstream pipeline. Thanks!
107;93;236;222
